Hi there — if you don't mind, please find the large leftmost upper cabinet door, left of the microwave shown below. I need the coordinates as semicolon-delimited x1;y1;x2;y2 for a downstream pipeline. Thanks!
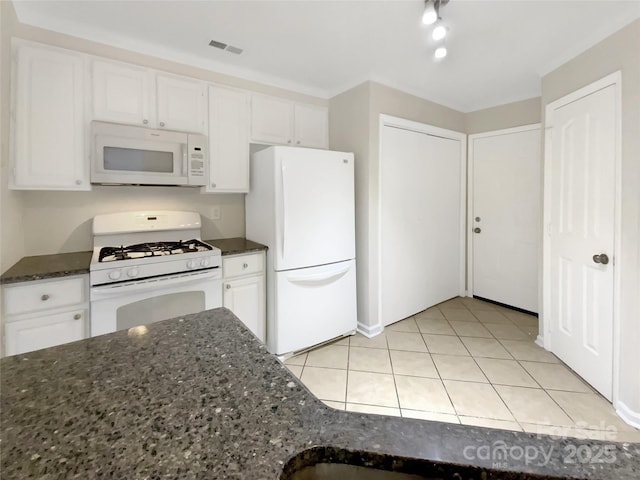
11;44;90;190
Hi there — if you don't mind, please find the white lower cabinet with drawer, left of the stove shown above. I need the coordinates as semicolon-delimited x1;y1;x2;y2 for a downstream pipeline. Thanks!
3;275;89;355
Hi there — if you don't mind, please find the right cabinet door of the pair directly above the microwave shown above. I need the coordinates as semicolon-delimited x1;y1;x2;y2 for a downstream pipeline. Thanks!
156;74;207;134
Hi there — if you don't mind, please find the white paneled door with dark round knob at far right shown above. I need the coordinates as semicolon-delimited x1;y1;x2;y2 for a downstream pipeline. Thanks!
545;81;617;399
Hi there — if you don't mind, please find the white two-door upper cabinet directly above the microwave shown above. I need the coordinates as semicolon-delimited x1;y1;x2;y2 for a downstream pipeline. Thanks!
92;59;207;133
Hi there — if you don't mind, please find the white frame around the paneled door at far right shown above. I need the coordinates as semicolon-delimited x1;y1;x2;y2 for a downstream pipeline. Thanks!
536;71;622;406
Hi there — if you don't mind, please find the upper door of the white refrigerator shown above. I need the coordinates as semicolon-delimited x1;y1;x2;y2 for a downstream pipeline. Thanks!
274;147;356;271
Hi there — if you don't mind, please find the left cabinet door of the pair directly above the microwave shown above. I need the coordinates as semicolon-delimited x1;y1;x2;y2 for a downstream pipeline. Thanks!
92;60;153;125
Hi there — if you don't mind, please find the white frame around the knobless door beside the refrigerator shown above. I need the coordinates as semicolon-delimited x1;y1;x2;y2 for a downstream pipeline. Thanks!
375;113;467;331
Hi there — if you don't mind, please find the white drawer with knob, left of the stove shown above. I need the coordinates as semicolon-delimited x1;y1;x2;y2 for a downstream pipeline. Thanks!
4;276;86;315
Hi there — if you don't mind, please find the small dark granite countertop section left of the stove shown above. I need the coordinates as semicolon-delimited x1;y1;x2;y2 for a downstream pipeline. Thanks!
0;252;92;284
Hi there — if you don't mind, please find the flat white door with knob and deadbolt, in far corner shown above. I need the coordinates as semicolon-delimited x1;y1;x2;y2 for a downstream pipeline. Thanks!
469;125;541;312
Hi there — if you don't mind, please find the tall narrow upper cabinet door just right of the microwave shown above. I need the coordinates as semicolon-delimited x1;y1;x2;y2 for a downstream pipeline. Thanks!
206;86;249;193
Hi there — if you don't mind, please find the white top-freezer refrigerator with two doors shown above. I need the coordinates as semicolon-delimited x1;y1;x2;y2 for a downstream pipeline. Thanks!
245;147;357;355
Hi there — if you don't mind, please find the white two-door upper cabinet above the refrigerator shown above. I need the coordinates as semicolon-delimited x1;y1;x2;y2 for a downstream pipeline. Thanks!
251;94;329;148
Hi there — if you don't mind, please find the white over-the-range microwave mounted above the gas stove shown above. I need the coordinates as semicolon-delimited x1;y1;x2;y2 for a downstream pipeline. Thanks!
91;121;209;187
